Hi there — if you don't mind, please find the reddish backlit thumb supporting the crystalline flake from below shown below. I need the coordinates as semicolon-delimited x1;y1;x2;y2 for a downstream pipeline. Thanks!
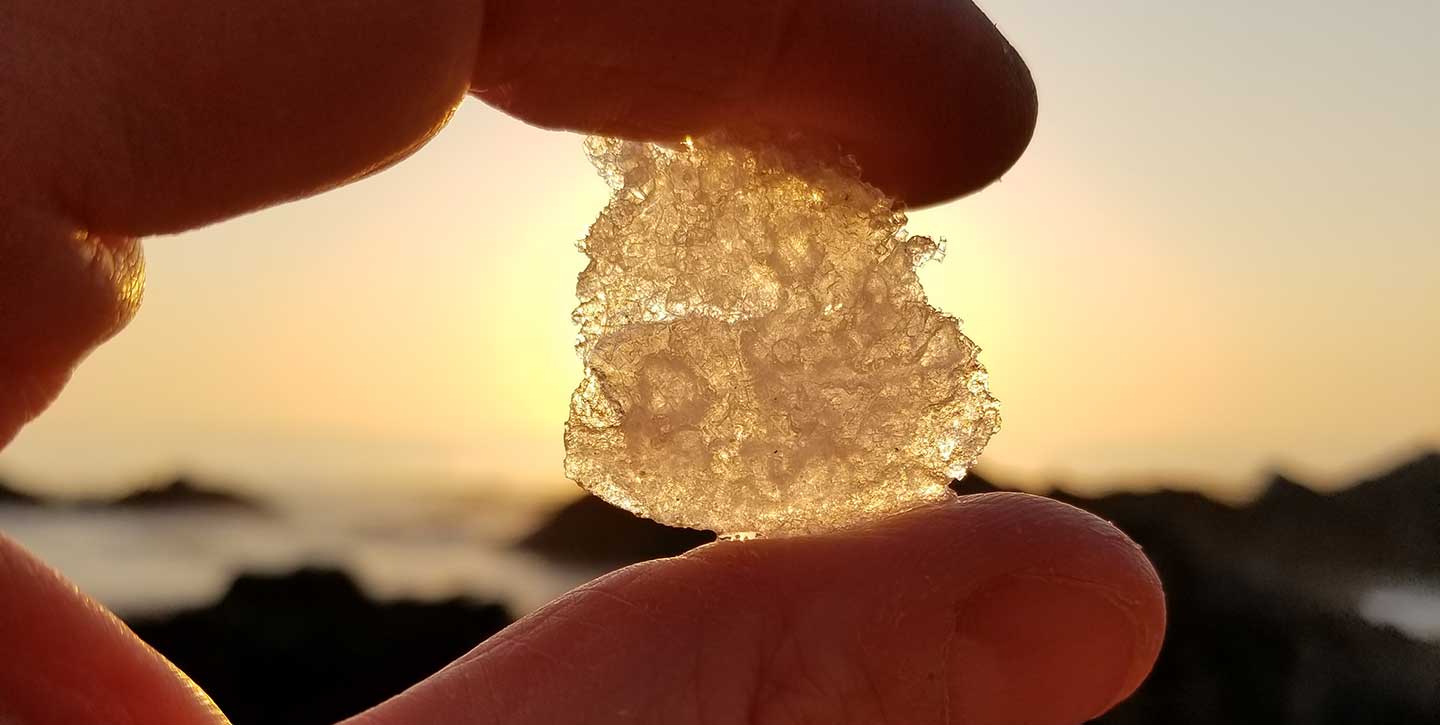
351;494;1165;725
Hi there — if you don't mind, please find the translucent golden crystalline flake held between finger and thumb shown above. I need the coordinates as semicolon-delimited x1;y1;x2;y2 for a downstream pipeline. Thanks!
564;137;999;536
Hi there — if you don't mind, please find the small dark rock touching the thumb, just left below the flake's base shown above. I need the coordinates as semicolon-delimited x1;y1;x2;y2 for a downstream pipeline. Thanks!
518;494;716;565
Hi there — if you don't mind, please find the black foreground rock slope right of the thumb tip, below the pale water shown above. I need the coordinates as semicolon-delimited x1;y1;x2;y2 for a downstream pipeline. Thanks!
1096;550;1440;725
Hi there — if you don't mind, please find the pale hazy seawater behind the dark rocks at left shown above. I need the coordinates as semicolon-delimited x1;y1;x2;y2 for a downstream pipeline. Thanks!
0;492;602;615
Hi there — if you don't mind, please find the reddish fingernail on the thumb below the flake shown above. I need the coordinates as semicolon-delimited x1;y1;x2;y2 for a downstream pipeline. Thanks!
952;574;1139;724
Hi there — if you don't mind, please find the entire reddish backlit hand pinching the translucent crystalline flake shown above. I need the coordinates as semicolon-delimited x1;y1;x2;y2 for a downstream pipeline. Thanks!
0;0;1165;725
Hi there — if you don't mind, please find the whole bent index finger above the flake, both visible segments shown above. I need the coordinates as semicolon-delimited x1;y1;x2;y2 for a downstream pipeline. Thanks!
22;0;1037;236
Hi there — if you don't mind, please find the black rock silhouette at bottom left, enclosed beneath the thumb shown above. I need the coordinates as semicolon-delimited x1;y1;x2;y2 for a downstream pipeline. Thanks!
130;569;511;725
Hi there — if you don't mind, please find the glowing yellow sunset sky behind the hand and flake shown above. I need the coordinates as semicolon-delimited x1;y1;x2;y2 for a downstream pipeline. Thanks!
0;0;1440;494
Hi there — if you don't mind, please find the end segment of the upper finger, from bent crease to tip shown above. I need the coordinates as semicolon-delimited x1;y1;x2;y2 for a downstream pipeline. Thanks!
474;0;1037;205
